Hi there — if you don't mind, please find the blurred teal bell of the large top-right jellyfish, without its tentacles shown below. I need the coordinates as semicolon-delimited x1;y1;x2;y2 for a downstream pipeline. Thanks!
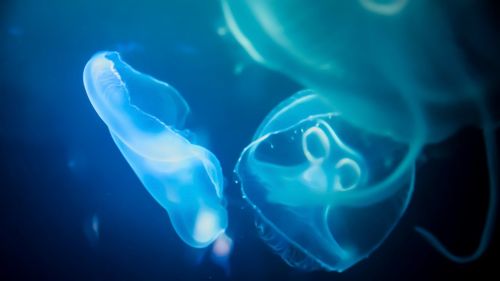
222;0;500;144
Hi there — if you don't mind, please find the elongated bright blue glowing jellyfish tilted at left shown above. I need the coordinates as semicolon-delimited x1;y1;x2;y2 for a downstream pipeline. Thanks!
83;52;227;248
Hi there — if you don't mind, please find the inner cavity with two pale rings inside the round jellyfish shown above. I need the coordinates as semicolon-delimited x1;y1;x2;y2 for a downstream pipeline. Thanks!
249;115;365;205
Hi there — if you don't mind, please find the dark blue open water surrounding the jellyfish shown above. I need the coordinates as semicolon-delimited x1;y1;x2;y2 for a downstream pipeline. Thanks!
0;0;500;280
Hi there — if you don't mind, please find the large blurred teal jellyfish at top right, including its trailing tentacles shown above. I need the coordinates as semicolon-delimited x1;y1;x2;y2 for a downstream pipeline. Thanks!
222;0;500;268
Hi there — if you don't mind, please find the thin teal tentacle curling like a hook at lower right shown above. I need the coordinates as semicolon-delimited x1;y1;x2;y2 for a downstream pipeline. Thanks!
415;122;498;263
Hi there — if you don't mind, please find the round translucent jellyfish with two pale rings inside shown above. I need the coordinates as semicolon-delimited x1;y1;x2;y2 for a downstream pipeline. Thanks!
235;91;414;271
